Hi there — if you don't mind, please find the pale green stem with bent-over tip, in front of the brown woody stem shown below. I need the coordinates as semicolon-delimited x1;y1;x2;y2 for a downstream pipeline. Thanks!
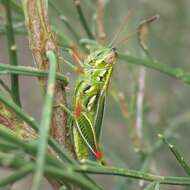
32;51;57;190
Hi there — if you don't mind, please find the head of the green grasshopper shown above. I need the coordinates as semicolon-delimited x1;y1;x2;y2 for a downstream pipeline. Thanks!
86;48;117;69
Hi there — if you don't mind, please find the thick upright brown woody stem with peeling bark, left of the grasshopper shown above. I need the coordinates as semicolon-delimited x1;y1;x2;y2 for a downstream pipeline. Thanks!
24;0;72;151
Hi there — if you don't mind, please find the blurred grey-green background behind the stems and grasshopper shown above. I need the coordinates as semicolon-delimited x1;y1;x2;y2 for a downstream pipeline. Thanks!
0;0;190;190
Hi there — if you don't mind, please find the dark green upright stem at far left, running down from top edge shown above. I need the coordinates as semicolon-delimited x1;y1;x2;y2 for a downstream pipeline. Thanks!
3;0;21;106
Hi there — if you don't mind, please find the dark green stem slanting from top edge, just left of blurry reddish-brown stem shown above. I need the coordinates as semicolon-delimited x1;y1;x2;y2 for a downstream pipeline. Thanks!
73;0;94;39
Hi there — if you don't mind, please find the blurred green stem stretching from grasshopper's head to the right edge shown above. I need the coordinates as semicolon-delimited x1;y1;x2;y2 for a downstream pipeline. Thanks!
119;53;190;84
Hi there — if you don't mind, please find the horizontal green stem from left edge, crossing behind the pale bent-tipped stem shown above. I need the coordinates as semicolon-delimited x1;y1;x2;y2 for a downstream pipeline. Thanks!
0;63;68;85
